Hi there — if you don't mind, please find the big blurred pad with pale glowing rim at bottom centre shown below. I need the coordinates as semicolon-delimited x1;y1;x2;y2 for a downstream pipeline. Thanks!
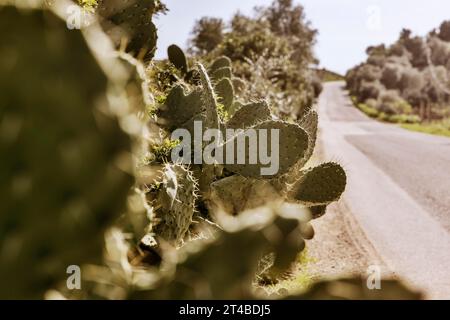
131;206;314;299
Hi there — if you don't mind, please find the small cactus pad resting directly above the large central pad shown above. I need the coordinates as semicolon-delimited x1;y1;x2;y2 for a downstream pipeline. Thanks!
226;101;272;129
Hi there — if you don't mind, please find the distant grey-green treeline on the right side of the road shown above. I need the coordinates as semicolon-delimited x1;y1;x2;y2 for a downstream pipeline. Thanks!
346;21;450;120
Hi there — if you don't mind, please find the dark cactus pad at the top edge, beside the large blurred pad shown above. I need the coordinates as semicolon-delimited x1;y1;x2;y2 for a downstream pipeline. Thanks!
96;0;157;61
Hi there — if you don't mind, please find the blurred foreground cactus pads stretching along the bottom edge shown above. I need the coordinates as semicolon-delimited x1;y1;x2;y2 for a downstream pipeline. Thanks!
62;205;422;300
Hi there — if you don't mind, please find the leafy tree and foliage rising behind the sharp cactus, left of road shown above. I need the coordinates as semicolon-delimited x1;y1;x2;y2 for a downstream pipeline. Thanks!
191;0;321;118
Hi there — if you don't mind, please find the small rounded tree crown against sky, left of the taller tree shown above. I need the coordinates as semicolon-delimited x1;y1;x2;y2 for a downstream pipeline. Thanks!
190;17;225;55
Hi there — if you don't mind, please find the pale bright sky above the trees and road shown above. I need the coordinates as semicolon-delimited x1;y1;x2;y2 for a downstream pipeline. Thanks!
156;0;450;74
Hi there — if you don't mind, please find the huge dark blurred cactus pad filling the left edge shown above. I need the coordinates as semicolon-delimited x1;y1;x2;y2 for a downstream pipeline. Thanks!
0;4;133;299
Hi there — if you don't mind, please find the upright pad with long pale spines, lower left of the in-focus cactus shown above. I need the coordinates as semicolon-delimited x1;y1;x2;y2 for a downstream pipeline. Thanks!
148;164;197;246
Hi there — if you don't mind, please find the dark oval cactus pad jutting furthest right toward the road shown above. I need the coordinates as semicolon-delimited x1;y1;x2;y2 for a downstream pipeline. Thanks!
293;163;347;205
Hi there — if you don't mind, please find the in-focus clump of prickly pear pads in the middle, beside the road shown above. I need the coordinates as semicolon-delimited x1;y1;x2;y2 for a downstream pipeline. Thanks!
153;43;346;231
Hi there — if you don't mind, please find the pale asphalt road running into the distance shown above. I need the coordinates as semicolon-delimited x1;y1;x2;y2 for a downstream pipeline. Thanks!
318;82;450;299
